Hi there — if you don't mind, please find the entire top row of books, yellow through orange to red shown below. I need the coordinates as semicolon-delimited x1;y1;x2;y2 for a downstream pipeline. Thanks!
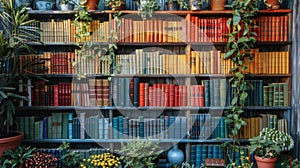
34;15;288;42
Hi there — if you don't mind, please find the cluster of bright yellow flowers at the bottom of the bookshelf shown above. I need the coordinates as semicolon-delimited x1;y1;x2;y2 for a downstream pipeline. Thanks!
80;152;121;168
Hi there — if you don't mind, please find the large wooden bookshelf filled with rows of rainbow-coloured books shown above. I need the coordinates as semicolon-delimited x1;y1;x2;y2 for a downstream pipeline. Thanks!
17;9;292;167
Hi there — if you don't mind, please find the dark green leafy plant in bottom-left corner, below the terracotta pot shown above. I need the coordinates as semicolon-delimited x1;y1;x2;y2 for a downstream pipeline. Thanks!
0;146;36;168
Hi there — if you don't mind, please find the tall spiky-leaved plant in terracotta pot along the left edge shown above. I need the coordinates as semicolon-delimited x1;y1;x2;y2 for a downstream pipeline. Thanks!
0;0;40;155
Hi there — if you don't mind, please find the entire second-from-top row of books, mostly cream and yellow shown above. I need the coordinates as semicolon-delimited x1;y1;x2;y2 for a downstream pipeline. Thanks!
19;49;289;74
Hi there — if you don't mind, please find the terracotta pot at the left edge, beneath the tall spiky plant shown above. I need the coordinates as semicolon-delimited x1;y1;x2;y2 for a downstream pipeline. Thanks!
0;131;24;156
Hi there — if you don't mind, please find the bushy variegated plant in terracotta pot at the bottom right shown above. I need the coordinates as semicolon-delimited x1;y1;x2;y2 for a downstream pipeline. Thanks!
249;128;294;168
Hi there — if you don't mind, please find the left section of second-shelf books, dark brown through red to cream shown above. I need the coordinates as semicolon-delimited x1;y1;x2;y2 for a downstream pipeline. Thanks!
19;50;110;74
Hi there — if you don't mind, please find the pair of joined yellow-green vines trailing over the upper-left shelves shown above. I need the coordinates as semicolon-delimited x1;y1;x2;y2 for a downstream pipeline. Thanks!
73;0;121;79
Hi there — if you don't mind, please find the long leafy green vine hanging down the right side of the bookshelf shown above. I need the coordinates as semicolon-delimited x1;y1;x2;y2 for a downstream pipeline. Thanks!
221;0;259;167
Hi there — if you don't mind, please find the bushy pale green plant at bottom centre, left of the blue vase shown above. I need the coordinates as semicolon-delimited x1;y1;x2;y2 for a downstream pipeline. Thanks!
117;138;162;168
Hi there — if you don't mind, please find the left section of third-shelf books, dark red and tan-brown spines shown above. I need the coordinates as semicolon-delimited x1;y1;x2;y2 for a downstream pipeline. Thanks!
19;79;110;106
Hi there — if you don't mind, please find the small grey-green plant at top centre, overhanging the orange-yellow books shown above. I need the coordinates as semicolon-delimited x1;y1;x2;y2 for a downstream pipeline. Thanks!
137;0;160;20
